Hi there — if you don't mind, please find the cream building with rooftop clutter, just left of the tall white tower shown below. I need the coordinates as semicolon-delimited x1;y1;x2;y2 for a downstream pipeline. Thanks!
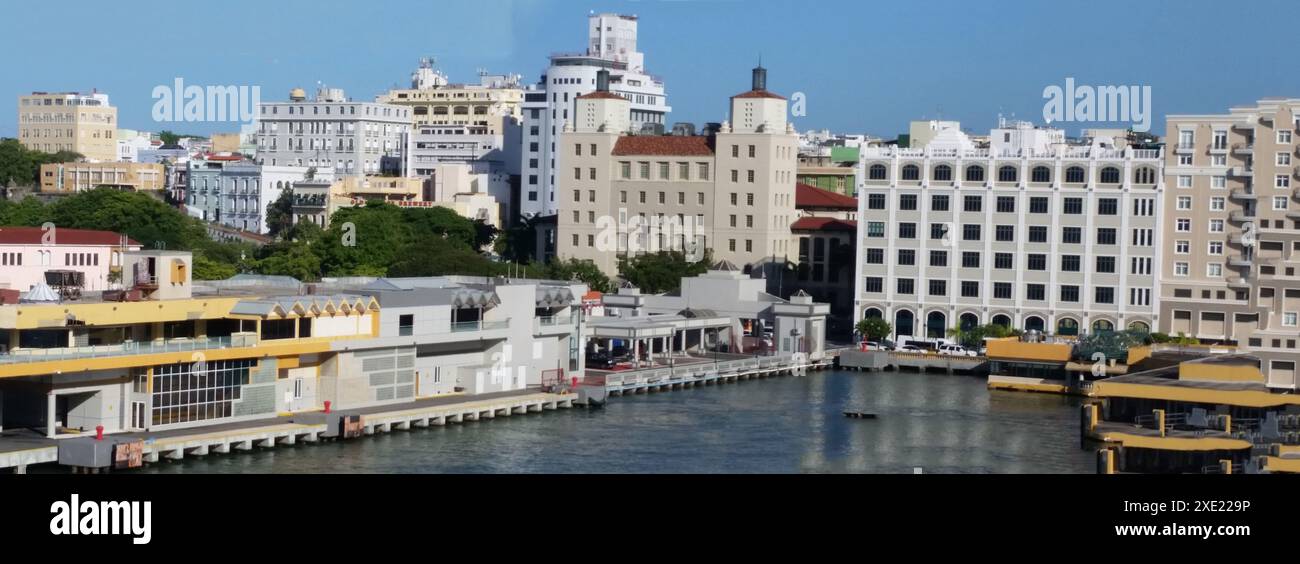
374;57;524;135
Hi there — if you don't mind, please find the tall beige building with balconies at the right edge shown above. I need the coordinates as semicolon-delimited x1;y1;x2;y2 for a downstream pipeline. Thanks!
1160;99;1300;389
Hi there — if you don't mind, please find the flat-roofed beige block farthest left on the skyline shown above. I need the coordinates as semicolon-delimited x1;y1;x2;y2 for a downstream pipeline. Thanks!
18;92;117;162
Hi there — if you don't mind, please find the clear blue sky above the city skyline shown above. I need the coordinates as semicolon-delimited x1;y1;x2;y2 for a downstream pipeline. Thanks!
0;0;1300;136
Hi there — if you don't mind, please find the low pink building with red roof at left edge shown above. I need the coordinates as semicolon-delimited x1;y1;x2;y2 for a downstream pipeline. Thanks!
0;227;140;292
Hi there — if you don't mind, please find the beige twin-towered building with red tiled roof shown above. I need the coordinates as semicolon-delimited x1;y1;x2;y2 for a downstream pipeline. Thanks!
558;68;798;279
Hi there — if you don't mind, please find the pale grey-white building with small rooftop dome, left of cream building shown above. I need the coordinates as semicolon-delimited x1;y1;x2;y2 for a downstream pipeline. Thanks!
256;88;411;175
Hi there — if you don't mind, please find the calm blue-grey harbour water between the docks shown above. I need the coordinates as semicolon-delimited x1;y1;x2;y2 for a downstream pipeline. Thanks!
134;370;1093;473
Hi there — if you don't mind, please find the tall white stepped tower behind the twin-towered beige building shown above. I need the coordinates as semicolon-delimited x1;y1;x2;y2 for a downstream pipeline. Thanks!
519;13;672;217
